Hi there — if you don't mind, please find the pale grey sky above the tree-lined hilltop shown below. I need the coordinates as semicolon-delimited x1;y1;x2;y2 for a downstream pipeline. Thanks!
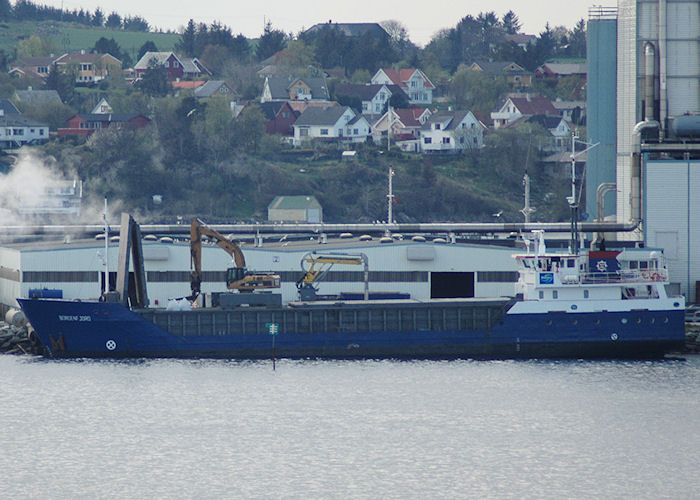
35;0;596;46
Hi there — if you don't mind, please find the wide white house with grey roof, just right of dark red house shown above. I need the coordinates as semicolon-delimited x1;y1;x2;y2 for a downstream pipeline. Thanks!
293;106;371;146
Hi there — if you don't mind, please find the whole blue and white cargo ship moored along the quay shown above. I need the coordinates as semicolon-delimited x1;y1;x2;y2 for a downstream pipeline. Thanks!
18;226;685;359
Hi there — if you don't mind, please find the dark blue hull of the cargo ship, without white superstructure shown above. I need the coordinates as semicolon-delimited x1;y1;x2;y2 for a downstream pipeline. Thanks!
18;299;685;359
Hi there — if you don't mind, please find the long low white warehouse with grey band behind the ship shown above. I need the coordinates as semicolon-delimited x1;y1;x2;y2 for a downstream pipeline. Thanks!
0;237;517;309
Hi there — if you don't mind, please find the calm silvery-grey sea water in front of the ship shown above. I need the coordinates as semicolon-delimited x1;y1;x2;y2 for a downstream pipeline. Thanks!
0;356;700;499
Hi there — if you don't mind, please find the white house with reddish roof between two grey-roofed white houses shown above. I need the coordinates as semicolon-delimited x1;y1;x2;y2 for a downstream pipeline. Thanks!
372;107;431;153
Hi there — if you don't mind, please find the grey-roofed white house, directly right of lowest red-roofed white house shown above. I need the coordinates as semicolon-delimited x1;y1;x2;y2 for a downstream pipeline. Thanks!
420;111;486;152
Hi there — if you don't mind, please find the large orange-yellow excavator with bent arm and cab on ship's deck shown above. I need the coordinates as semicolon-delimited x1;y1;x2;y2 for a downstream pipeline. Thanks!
189;218;280;300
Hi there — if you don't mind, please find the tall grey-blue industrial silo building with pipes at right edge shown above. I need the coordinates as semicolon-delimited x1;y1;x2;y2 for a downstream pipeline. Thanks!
586;0;700;302
